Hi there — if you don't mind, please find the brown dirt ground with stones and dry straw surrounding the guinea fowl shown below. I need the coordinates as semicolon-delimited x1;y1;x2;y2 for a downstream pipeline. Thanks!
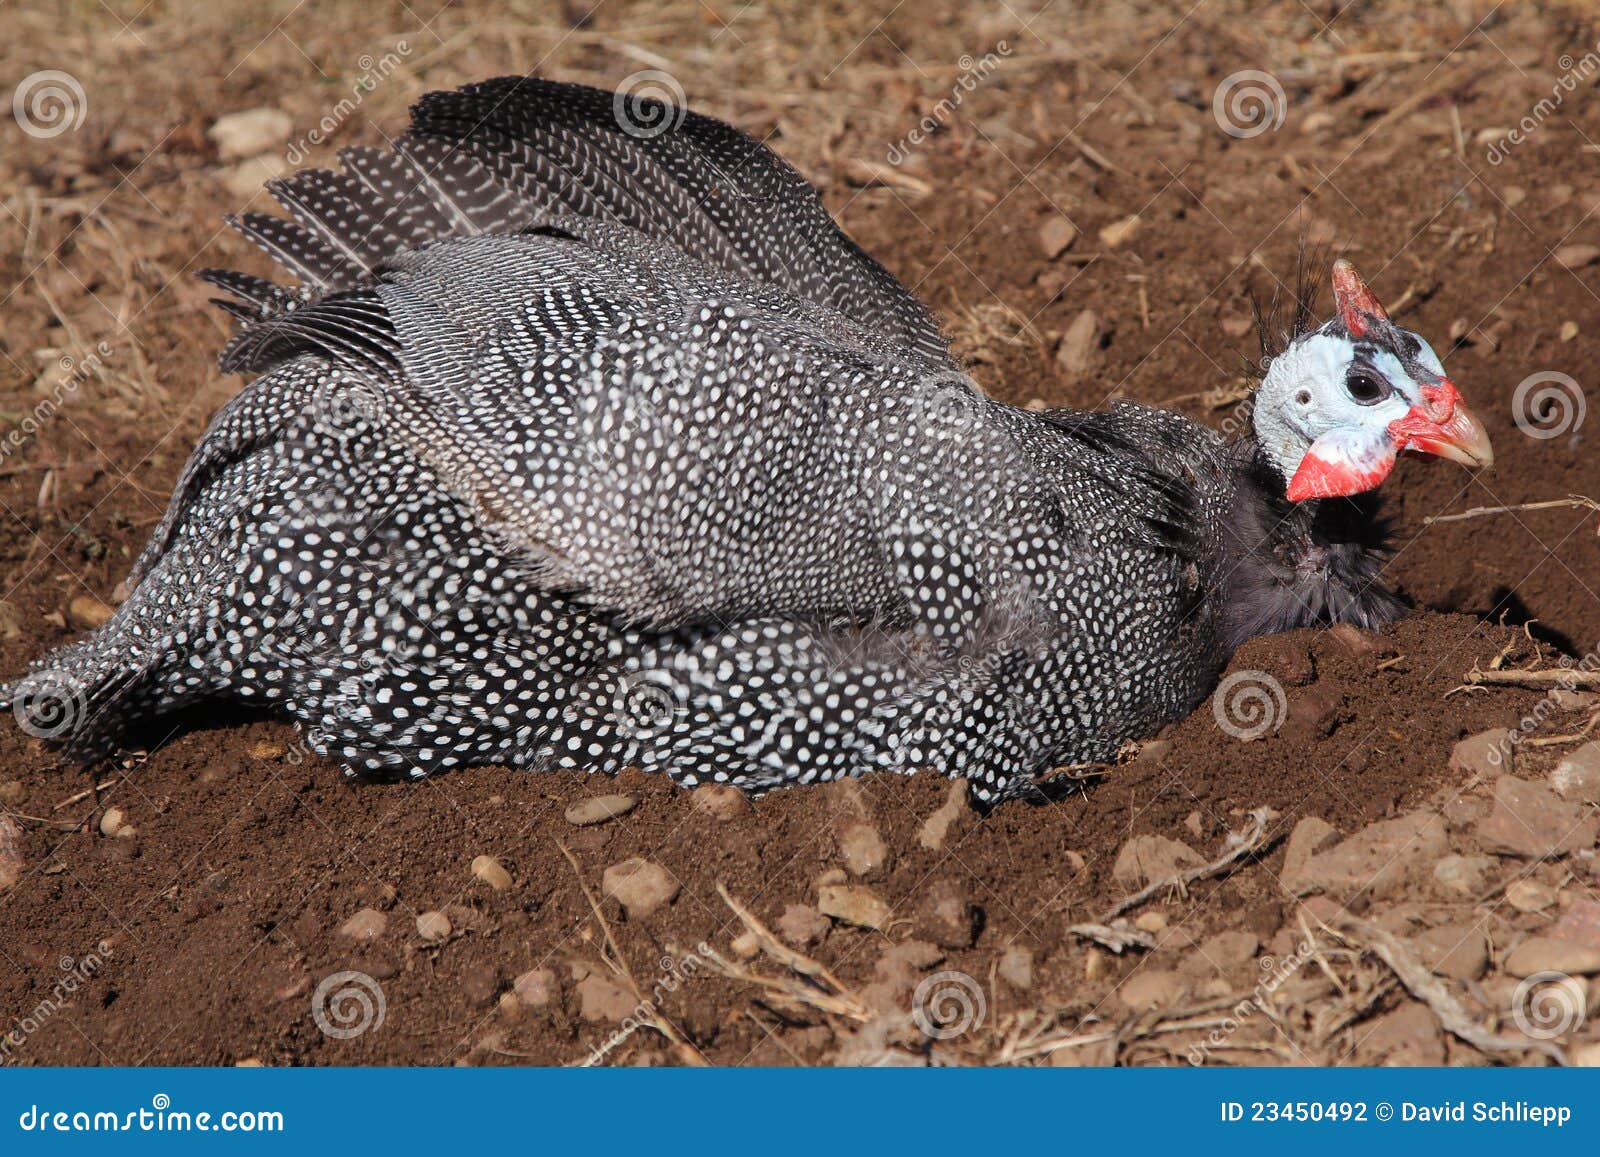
0;0;1600;1064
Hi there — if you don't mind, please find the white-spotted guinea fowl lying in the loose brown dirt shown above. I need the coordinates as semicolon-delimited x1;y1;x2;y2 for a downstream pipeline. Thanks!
0;77;1490;802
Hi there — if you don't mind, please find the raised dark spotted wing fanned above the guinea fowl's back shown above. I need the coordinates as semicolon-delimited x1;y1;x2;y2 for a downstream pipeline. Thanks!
202;77;947;365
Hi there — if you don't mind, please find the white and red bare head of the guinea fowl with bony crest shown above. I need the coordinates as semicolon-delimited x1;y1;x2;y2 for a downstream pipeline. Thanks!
1253;261;1494;502
